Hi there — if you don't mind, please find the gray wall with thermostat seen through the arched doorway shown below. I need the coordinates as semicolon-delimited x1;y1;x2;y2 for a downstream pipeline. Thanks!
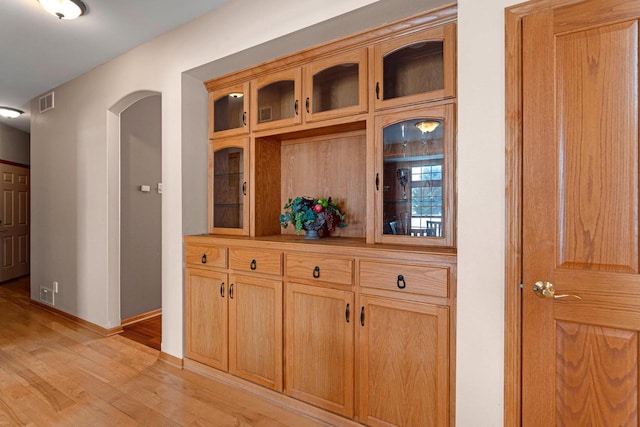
120;96;162;319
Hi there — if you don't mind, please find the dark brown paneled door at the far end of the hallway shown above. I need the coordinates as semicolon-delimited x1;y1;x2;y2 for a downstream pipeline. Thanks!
0;163;30;282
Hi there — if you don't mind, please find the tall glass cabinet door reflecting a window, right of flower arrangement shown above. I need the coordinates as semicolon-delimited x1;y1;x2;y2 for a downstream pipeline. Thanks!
376;105;455;246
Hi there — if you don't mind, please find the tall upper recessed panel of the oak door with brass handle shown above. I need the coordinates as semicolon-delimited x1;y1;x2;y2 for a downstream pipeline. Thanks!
549;21;638;272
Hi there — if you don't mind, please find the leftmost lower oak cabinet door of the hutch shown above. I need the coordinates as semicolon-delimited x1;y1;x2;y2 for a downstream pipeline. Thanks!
185;268;228;371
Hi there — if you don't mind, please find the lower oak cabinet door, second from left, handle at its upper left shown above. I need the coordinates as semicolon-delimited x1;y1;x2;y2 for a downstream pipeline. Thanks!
229;275;282;391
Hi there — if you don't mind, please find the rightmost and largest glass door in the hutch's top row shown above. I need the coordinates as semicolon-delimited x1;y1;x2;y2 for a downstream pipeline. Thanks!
374;24;455;109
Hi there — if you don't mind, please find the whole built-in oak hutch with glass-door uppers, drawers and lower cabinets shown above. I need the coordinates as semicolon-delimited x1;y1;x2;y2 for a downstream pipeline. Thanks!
184;6;456;426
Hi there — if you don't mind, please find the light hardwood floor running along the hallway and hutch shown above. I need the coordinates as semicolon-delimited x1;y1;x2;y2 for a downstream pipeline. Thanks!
0;278;327;427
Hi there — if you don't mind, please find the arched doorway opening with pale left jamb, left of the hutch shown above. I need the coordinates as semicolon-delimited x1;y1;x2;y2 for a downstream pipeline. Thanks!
107;91;162;334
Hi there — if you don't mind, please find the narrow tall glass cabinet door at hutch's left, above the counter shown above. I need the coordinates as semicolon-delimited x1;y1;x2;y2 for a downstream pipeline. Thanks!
209;138;249;235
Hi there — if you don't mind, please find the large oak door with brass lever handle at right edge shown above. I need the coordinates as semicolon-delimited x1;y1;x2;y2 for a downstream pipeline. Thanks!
522;0;640;427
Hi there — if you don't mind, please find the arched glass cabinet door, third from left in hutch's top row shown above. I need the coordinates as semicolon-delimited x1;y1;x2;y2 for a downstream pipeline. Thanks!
304;49;367;122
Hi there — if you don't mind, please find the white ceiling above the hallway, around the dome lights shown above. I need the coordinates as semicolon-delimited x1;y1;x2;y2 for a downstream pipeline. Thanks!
0;0;229;132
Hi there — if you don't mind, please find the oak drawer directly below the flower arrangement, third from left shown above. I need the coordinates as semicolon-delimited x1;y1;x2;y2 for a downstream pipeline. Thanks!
287;254;353;285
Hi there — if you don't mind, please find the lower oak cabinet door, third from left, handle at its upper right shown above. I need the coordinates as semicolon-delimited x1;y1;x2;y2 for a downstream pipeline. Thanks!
285;283;357;417
